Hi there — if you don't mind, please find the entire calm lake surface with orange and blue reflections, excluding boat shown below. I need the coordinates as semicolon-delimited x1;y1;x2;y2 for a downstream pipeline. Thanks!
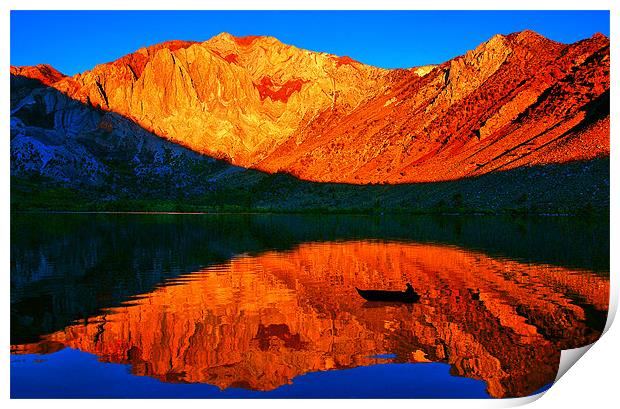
11;214;609;398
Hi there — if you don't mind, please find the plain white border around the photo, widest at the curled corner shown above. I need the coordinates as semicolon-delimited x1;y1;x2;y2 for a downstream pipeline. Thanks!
0;0;620;409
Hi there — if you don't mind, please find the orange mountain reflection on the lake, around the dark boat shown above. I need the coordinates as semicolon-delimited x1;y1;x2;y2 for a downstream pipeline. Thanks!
11;241;609;397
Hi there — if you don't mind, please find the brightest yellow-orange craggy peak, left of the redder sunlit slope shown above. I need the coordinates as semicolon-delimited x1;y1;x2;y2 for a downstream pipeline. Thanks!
46;34;384;166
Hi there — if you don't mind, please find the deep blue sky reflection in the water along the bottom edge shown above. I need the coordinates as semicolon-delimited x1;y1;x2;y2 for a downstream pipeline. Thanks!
11;348;489;399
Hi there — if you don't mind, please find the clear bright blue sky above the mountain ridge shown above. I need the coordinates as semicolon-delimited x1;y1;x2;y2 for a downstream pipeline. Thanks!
11;11;609;75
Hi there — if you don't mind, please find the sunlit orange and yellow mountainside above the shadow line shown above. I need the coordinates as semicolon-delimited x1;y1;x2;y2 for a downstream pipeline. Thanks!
12;31;609;184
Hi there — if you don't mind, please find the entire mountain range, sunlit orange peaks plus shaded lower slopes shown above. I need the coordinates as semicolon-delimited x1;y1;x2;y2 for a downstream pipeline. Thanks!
11;31;610;208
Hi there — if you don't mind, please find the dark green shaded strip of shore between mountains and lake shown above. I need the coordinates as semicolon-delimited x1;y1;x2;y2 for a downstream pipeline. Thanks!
11;158;609;214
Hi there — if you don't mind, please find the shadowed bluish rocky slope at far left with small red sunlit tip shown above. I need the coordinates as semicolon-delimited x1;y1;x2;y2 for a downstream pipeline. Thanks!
11;73;241;195
